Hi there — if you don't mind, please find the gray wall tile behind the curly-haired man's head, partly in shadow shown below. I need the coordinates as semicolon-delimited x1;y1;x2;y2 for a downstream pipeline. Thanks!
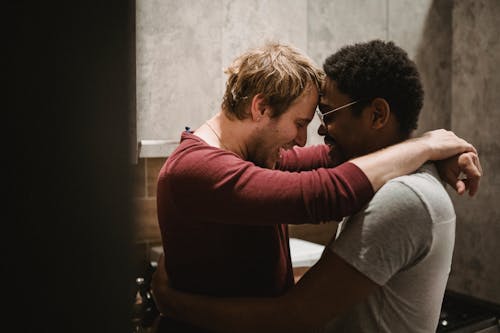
410;0;453;134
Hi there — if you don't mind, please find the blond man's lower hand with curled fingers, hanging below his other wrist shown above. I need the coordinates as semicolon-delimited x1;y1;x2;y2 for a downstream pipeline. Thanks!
436;152;483;196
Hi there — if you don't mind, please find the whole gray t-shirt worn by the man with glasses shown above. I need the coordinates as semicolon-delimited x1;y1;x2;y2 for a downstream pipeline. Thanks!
325;164;455;333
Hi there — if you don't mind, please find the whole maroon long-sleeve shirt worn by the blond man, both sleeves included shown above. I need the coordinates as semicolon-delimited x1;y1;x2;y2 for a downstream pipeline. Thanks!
157;132;373;296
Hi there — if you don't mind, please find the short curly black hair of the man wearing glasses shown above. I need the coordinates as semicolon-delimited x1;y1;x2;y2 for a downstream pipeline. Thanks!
323;39;424;136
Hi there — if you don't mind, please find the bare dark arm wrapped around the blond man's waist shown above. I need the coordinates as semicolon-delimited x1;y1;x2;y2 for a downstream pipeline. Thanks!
152;250;378;333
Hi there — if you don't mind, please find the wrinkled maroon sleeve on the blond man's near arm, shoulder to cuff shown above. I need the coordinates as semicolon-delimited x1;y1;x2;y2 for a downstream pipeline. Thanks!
166;151;373;225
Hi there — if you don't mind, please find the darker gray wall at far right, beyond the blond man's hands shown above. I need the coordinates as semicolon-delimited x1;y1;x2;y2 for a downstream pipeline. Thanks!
449;0;500;304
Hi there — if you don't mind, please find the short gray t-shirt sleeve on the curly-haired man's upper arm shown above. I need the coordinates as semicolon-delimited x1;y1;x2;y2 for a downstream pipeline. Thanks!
328;180;432;285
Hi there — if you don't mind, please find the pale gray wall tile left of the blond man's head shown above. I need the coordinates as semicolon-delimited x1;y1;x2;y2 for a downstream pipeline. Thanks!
137;0;223;139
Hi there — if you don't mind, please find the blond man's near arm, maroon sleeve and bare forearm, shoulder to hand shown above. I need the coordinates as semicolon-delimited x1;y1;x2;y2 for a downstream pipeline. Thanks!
157;130;480;225
